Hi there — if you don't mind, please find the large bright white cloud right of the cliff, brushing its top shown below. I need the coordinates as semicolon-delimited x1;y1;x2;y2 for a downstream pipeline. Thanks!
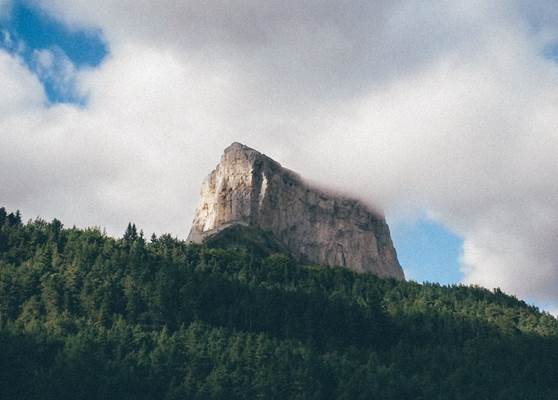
302;28;558;301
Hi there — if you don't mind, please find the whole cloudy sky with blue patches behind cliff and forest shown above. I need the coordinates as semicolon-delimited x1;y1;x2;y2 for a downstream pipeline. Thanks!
0;0;558;312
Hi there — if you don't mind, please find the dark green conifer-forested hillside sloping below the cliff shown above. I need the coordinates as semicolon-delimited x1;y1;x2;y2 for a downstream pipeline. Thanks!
0;208;558;400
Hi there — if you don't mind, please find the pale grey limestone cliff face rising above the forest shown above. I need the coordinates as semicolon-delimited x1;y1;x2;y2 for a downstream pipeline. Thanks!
188;143;404;279
